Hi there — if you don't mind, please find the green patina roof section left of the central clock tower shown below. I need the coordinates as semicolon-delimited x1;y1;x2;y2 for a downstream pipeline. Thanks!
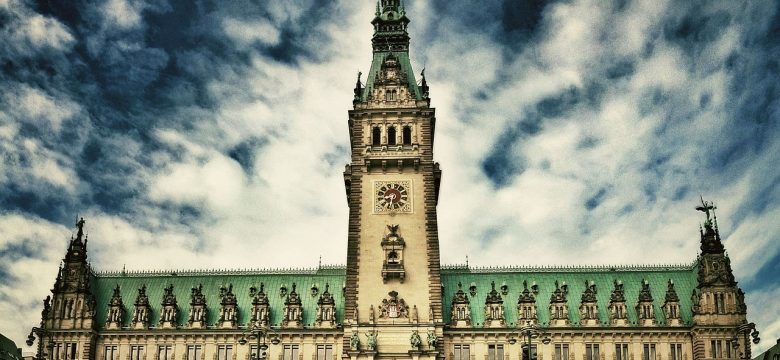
91;267;345;328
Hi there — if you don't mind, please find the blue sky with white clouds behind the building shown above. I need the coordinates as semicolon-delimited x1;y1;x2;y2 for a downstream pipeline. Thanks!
0;0;780;349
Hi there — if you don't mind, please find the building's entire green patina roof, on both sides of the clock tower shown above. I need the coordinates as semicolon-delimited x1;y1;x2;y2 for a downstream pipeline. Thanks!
92;264;697;328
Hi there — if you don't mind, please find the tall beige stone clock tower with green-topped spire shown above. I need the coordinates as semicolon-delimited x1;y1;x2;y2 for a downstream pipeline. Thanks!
344;0;443;359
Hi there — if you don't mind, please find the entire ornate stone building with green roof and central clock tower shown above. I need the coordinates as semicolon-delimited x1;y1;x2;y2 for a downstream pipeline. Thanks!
30;0;751;360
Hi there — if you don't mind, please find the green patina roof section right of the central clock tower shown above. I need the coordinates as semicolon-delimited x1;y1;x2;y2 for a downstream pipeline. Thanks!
441;265;697;327
